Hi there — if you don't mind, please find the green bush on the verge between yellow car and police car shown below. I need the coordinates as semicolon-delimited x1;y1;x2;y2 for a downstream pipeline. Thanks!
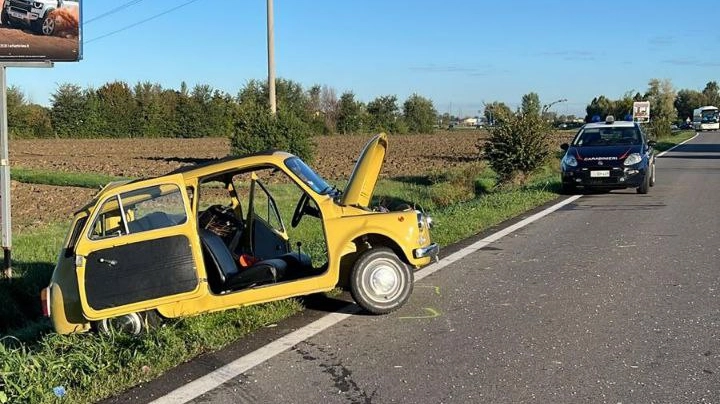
477;112;553;184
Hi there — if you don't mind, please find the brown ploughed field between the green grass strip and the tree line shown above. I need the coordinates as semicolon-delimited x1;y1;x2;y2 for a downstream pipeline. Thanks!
10;131;485;180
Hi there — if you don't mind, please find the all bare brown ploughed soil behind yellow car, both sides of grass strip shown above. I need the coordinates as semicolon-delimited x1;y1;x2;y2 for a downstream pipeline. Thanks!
4;130;568;229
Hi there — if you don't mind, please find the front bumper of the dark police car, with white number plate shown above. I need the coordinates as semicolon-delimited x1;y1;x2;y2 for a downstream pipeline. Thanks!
562;167;646;188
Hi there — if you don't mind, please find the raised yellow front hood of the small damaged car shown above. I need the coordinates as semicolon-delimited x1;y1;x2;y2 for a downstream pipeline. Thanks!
339;133;387;208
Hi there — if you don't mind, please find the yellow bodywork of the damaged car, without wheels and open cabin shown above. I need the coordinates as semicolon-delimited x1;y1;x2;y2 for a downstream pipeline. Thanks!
48;134;437;334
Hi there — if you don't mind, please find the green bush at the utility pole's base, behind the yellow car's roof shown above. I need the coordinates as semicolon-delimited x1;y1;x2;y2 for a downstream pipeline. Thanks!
230;107;313;161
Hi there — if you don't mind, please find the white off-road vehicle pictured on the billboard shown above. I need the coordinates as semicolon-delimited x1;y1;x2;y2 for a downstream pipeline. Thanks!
0;0;80;35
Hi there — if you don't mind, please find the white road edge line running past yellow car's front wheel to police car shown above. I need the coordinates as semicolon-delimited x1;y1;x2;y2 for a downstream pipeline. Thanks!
152;195;582;404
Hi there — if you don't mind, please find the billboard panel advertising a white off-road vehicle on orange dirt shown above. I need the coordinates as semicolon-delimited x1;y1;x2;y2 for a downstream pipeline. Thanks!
0;0;82;63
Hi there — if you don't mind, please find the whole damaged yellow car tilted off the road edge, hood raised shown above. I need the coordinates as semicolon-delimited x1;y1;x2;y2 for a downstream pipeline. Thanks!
41;134;438;334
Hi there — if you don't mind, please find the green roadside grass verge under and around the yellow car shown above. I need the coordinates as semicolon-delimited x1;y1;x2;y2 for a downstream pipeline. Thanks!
0;133;693;404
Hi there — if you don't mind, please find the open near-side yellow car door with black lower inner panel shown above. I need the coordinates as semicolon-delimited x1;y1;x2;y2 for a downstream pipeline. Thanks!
75;175;202;320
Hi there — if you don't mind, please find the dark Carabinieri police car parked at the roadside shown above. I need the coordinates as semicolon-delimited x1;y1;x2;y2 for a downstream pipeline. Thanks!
560;115;656;194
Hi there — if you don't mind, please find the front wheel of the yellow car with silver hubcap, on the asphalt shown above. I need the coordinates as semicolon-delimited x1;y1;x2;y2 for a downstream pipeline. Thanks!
350;247;413;314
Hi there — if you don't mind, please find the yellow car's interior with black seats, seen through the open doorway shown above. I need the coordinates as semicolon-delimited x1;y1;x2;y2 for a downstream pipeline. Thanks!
197;167;325;294
